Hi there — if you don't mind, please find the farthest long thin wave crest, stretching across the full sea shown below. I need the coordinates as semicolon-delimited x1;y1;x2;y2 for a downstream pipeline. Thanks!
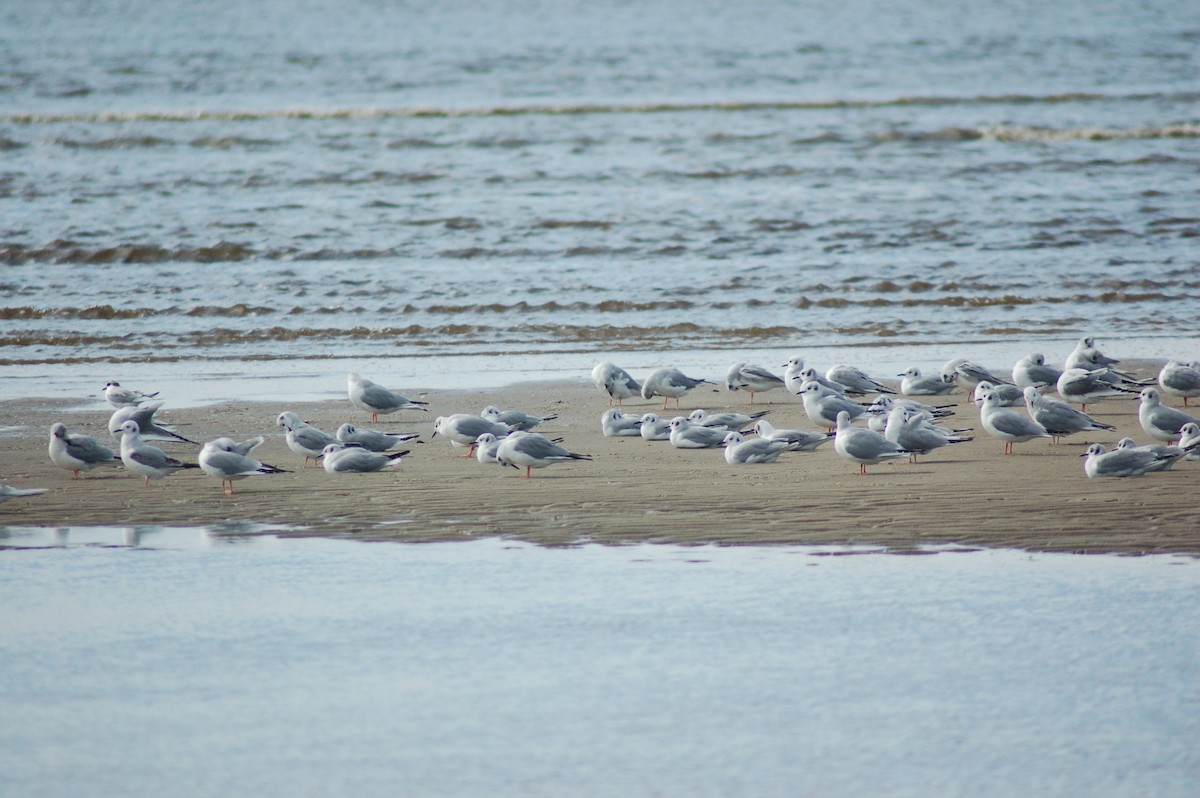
0;91;1200;124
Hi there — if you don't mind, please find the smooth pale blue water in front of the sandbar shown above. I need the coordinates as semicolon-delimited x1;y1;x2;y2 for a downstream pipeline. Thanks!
0;526;1200;797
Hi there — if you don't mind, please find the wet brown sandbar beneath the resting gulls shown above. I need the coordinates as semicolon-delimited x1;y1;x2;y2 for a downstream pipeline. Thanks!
0;372;1200;554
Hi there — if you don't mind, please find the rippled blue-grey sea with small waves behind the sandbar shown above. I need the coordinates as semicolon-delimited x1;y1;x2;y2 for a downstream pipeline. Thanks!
0;0;1200;402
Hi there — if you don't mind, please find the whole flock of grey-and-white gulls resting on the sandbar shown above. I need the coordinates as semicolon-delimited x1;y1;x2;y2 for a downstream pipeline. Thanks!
0;337;1200;502
